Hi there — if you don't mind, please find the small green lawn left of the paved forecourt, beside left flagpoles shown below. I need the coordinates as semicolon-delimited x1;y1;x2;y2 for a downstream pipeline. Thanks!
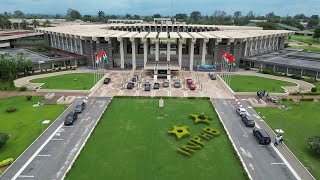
31;73;94;90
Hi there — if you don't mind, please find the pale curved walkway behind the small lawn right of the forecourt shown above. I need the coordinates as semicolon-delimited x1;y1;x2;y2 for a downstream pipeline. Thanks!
232;71;314;91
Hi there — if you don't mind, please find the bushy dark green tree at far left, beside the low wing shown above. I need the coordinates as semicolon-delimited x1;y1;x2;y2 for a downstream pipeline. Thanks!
0;53;32;87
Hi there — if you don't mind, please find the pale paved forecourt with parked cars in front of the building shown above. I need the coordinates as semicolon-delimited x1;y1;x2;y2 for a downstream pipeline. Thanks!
92;70;234;99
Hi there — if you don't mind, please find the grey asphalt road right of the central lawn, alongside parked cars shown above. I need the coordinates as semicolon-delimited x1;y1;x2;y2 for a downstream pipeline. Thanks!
212;99;297;180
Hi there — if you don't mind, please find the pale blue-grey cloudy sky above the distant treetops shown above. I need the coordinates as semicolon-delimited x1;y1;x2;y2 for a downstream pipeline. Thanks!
0;0;320;16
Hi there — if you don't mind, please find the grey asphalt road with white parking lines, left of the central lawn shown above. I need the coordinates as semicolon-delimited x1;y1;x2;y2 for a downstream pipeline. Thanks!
1;97;111;180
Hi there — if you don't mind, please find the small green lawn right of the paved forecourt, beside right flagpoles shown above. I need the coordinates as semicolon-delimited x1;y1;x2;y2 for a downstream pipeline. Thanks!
230;75;296;92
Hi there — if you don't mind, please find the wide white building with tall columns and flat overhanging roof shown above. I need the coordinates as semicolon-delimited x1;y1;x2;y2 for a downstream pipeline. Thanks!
37;18;293;78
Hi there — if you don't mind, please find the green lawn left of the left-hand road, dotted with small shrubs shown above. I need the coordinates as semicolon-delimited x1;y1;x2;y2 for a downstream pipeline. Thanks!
0;96;66;161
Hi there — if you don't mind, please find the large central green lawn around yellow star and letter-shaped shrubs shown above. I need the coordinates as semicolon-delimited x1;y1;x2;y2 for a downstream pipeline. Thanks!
66;98;247;180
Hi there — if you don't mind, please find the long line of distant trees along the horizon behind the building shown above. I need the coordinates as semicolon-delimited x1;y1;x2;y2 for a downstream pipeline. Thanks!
0;8;319;30
